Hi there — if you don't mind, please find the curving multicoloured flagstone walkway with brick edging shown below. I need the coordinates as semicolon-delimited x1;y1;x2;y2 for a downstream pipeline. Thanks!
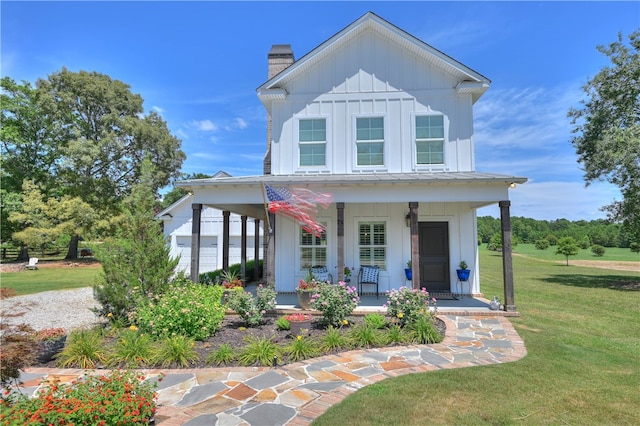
16;315;526;426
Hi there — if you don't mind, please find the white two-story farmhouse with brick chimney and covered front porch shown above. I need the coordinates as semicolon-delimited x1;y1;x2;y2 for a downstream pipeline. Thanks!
179;13;526;309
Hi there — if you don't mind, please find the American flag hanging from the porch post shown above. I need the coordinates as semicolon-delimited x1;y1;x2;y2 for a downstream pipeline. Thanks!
264;184;332;237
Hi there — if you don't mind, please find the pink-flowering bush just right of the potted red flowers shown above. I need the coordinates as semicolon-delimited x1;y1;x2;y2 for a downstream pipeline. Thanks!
311;281;360;327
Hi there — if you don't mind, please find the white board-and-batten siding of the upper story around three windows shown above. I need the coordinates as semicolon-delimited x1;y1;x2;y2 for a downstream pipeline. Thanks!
272;30;475;174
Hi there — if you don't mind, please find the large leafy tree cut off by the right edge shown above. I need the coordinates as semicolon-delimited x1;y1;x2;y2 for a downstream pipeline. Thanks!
568;31;640;241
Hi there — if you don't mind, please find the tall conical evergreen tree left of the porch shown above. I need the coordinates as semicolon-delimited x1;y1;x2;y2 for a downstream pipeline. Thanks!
93;158;179;321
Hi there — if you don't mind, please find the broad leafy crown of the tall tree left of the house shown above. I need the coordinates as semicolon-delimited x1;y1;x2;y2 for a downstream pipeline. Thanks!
37;68;185;214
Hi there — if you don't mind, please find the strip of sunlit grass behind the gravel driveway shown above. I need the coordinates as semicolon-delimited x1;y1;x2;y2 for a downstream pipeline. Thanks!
0;265;102;295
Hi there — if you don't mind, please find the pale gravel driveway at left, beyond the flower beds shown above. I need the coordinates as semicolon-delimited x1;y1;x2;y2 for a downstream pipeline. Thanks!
0;287;101;330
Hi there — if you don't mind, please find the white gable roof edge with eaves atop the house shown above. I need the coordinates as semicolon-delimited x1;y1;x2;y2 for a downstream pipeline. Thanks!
256;12;491;105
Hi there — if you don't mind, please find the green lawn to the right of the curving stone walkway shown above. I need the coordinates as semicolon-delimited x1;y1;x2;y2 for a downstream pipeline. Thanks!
313;250;640;426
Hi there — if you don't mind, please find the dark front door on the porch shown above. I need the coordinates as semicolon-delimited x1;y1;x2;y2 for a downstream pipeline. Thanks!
418;222;451;292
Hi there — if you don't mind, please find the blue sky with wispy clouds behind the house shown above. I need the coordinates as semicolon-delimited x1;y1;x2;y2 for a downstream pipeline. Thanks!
0;0;640;220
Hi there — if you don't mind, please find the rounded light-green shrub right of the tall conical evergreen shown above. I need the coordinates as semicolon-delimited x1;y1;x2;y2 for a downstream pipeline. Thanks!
131;279;225;340
